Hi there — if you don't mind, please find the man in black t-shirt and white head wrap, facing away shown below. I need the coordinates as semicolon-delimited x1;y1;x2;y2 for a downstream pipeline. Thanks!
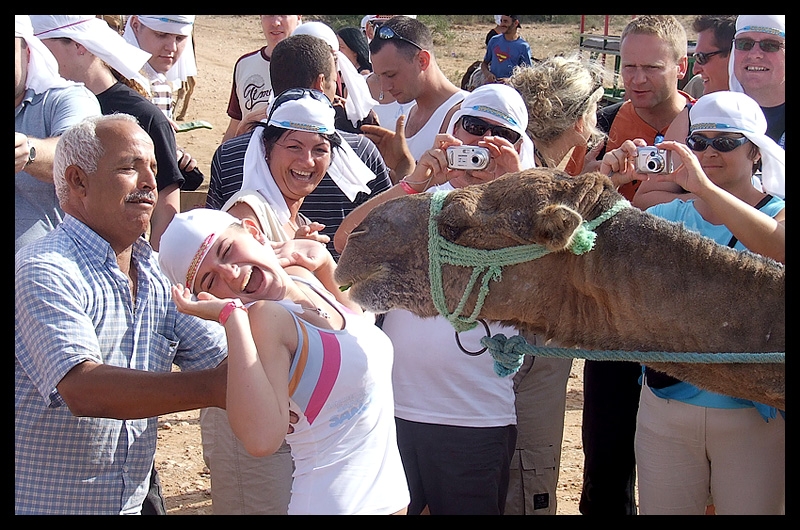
31;15;191;250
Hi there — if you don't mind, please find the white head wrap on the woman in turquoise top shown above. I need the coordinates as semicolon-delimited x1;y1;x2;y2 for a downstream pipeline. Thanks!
689;90;786;199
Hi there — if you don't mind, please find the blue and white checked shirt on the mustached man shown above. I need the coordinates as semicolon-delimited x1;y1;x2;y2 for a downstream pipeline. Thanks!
14;215;227;514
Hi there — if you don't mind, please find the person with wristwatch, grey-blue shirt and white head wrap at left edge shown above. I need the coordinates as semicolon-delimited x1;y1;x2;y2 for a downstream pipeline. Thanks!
14;15;100;252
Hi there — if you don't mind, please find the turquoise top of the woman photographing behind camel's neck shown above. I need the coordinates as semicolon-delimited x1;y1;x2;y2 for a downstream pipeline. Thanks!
647;197;786;420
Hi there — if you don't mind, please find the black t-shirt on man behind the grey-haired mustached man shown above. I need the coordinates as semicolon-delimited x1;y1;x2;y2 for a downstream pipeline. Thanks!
97;83;184;191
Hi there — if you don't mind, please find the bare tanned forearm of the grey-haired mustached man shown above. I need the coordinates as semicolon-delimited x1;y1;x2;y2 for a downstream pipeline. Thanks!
57;360;228;419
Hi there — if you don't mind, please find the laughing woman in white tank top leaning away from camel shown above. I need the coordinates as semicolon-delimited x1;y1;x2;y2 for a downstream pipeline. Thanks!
159;208;416;515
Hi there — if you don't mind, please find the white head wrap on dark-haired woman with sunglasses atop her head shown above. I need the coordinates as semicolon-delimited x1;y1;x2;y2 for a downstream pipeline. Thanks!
241;94;375;224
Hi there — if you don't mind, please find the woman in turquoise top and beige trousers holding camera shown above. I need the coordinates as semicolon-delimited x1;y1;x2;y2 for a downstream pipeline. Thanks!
601;91;786;515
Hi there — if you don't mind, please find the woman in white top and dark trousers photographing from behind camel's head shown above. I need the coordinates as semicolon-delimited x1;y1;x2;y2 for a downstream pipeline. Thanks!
334;84;533;515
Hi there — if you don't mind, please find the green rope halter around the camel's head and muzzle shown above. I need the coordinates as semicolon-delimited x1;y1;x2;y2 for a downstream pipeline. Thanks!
428;190;630;332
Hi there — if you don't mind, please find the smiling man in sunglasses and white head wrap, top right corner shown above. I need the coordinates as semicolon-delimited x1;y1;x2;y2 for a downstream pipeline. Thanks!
729;15;786;149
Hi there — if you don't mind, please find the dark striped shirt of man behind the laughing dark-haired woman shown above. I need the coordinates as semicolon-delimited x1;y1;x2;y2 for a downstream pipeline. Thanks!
206;131;392;259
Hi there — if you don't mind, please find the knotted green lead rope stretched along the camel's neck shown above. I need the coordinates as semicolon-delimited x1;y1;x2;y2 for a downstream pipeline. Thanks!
481;333;786;377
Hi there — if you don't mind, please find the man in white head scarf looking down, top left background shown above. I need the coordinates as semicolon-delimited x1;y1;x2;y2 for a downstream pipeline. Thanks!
123;15;197;119
